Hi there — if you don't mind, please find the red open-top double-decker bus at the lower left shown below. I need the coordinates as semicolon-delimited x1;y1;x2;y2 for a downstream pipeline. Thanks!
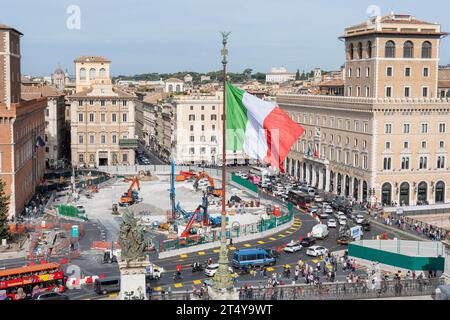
0;263;67;300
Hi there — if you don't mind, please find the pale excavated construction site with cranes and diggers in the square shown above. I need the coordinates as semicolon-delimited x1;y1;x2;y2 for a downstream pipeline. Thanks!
56;167;292;255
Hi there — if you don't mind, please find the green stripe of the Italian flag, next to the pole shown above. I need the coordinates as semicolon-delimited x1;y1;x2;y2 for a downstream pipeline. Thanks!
226;82;248;151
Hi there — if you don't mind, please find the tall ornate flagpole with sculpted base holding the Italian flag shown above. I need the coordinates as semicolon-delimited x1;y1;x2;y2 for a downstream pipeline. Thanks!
213;32;233;291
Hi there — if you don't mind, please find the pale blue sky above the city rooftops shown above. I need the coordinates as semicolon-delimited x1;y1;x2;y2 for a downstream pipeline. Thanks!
0;0;450;75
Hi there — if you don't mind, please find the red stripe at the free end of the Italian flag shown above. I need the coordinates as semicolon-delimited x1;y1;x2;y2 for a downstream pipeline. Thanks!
263;107;305;172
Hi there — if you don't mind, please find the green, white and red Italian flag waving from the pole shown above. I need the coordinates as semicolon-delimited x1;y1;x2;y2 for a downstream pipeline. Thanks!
226;83;305;172
